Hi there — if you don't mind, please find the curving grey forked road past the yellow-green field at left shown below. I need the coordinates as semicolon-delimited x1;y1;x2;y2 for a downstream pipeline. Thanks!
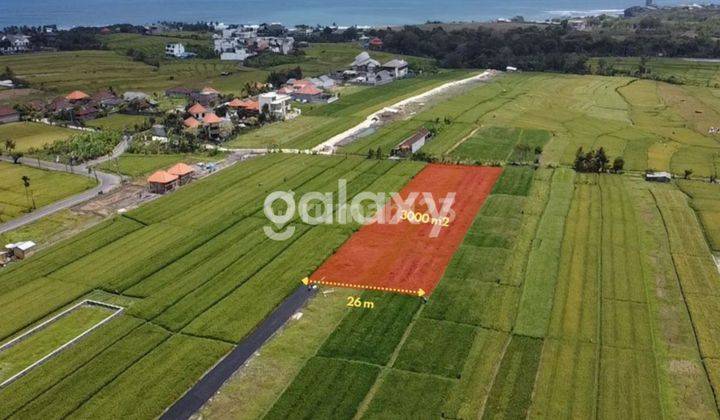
0;140;128;234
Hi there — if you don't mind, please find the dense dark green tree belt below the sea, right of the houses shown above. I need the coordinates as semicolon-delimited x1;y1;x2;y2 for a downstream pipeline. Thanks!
370;21;720;74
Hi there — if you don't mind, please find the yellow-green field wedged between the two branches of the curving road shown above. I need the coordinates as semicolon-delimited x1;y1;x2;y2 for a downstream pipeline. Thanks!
0;162;95;222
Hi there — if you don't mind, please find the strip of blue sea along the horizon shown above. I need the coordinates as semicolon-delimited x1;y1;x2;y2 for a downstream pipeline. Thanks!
0;0;680;28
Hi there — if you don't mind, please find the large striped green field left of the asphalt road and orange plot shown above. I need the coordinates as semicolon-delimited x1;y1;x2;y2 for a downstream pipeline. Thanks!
0;155;423;417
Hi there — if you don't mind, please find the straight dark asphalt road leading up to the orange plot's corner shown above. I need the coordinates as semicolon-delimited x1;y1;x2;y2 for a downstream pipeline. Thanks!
160;285;316;420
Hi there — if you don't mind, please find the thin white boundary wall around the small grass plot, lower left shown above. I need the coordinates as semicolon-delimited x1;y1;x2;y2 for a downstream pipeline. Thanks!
0;299;125;389
